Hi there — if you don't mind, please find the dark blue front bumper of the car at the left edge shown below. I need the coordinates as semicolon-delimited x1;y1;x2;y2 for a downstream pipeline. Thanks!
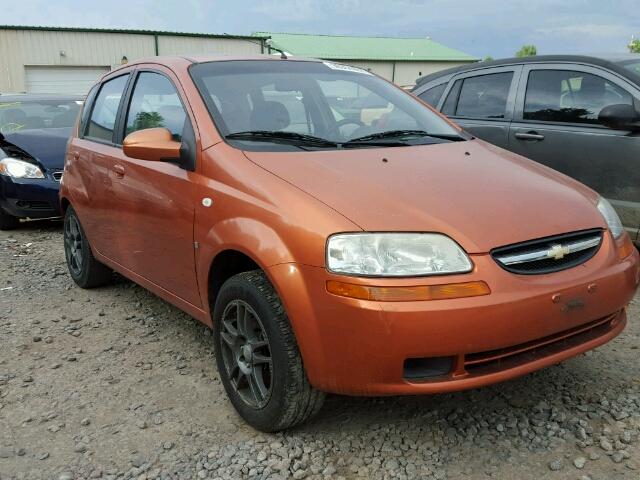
0;175;62;218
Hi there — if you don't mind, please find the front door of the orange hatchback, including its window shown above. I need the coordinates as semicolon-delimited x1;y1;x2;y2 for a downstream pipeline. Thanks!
113;67;201;306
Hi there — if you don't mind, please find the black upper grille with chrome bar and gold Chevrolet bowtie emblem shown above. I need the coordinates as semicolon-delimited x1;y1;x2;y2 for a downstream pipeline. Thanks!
491;229;602;275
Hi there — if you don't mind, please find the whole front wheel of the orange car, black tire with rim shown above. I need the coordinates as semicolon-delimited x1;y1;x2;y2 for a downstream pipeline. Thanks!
213;270;325;432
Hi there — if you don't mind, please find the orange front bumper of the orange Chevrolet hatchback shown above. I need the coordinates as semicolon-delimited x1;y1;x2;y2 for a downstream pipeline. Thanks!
269;234;640;395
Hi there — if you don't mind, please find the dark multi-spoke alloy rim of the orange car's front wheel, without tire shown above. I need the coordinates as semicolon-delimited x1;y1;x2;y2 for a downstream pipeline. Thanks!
220;300;273;409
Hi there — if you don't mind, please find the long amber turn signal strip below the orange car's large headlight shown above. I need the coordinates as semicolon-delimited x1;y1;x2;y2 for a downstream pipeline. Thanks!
327;280;491;302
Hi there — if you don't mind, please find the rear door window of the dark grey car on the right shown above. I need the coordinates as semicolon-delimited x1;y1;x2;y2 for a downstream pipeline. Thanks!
455;72;513;118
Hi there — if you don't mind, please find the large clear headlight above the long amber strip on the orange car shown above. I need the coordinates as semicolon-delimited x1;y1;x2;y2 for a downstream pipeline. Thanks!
327;233;473;277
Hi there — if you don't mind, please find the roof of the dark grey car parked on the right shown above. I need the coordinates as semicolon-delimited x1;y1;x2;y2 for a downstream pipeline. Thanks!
414;54;640;90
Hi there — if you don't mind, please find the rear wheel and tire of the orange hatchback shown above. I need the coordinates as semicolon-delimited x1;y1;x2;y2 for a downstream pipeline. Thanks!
64;206;113;288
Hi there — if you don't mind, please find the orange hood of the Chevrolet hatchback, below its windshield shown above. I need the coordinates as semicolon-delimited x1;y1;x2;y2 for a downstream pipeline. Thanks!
244;140;606;253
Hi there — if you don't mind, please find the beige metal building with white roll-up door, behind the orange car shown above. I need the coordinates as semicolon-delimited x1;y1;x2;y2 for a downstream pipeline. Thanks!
0;26;265;94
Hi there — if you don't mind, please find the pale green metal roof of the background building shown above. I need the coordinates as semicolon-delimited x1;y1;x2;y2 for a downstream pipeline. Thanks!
254;32;478;62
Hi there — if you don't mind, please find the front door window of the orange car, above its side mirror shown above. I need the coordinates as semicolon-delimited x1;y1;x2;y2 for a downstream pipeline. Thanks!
125;72;187;141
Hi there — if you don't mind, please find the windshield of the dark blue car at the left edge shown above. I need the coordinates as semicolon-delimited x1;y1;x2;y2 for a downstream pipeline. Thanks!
0;100;82;135
